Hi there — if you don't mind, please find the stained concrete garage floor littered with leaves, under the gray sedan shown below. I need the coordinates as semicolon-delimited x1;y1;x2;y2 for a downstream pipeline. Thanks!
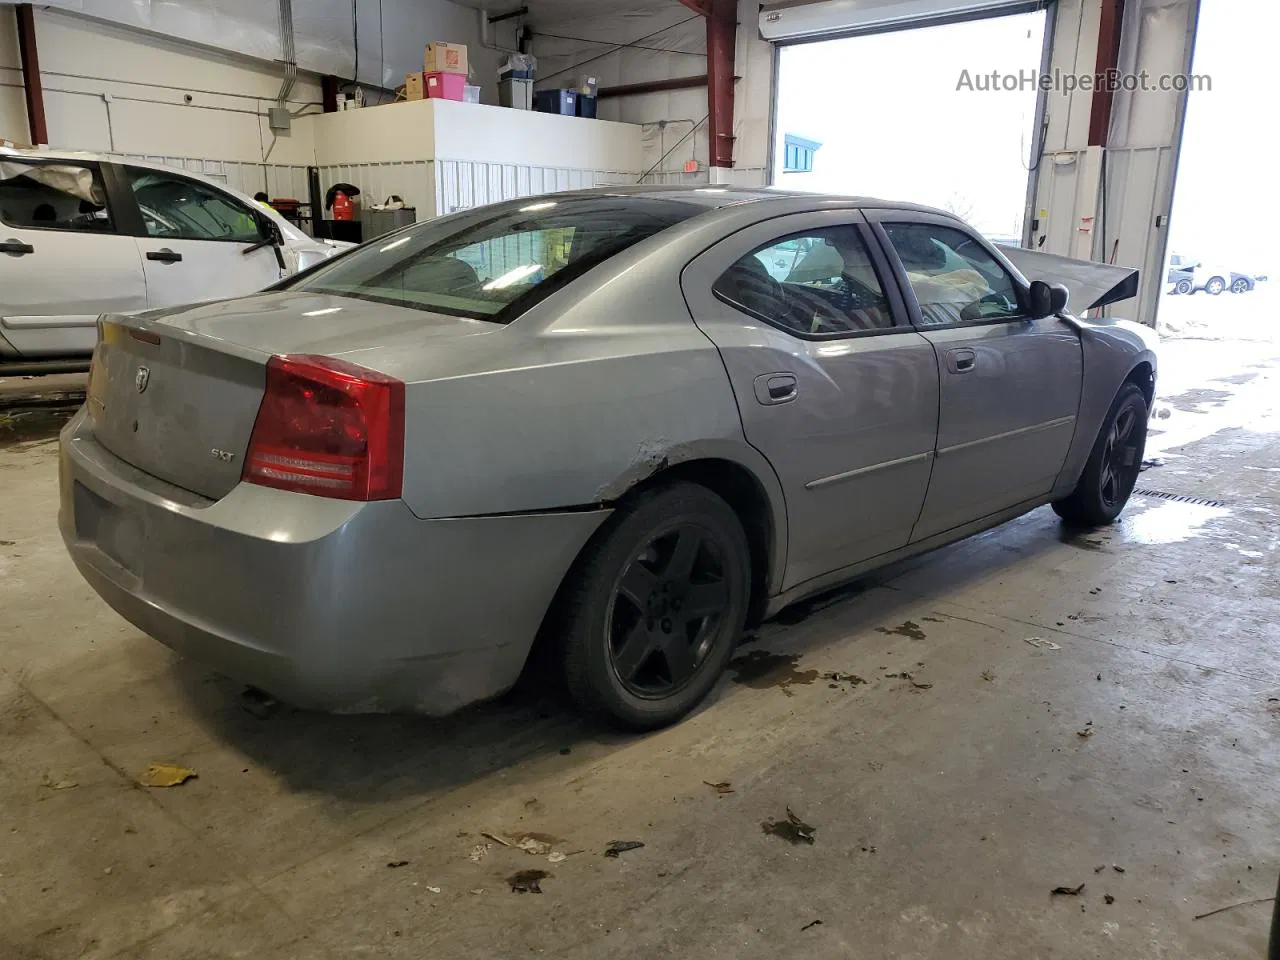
0;320;1280;960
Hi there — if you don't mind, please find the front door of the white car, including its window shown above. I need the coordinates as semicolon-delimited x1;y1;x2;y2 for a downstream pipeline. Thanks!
124;166;284;308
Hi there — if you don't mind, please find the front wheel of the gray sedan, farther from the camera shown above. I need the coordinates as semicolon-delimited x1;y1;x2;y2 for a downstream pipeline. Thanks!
1053;383;1148;527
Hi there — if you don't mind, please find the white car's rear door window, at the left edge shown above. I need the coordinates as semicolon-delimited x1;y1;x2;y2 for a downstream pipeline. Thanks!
0;159;114;232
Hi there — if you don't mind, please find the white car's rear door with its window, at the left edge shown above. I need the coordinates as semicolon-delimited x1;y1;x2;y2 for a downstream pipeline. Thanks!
0;156;147;358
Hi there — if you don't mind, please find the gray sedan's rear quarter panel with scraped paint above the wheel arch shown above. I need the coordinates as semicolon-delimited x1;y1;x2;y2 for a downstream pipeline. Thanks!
389;244;785;543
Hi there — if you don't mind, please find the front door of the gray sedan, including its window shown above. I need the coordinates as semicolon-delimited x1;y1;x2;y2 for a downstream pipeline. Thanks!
868;210;1083;540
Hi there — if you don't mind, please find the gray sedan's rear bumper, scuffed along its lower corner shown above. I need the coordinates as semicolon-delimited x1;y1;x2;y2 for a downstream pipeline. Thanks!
59;412;608;716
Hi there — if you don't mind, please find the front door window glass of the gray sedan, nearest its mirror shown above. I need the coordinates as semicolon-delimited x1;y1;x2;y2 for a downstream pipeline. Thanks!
884;223;1023;326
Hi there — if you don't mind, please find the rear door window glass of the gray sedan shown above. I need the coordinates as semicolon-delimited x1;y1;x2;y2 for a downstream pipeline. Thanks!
712;227;893;337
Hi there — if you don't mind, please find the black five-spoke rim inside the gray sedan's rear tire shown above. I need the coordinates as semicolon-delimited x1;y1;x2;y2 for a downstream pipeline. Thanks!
608;522;730;698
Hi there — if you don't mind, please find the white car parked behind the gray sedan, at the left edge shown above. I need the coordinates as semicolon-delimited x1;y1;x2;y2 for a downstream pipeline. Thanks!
0;148;340;366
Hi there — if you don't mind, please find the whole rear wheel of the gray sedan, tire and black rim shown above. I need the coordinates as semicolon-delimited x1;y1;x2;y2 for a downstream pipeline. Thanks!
559;483;751;731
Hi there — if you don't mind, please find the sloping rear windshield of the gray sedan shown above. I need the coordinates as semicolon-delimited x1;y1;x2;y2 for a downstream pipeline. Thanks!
291;196;705;324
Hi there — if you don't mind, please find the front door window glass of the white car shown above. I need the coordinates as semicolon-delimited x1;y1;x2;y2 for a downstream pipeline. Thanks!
128;166;262;243
